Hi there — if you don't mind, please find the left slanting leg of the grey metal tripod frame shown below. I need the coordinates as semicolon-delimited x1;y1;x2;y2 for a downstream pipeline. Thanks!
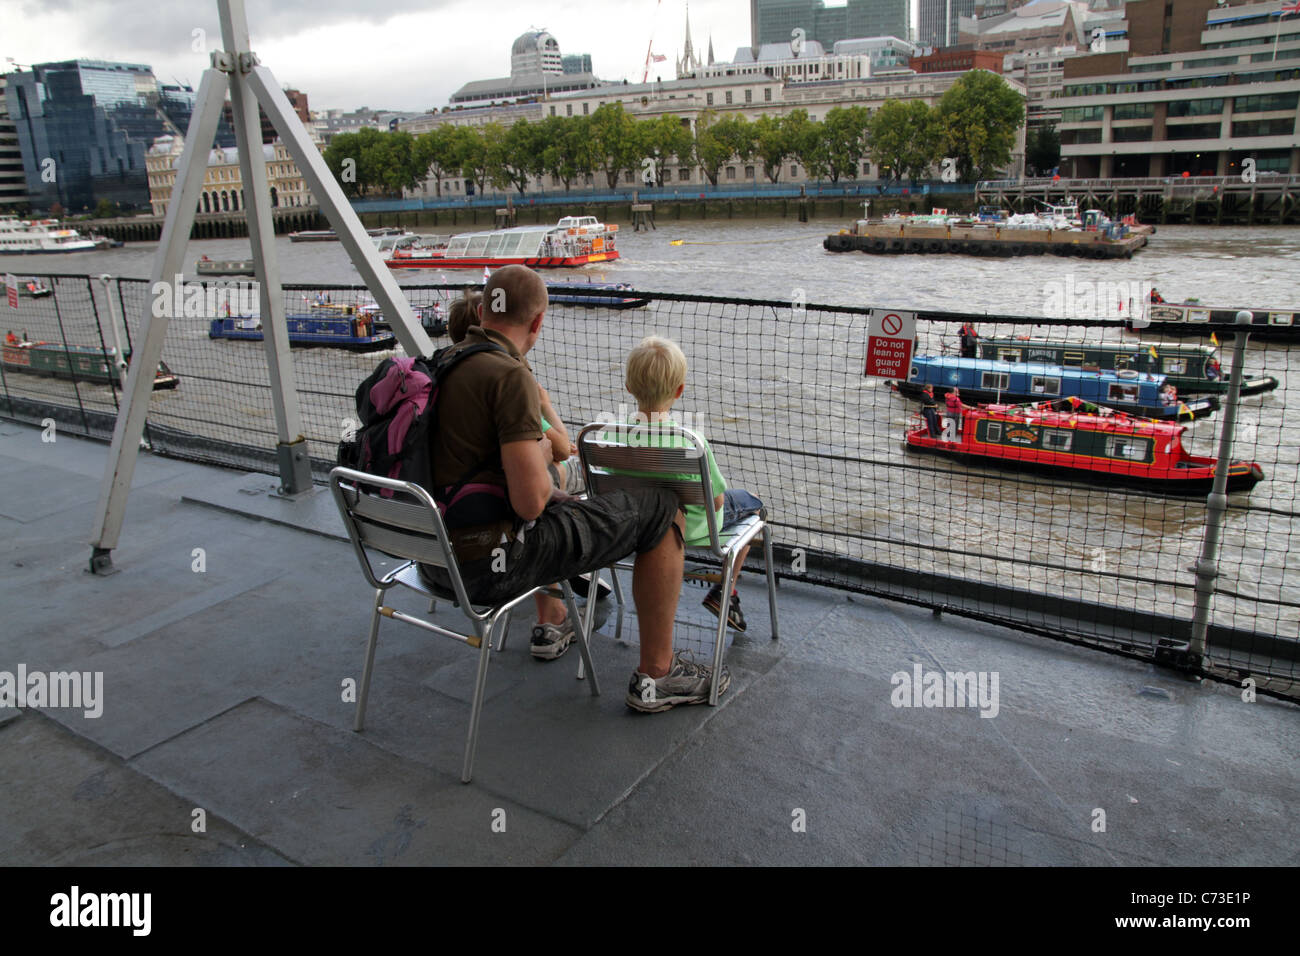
90;69;226;574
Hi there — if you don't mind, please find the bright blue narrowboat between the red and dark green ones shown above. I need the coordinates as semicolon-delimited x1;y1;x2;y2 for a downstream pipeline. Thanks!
893;355;1219;419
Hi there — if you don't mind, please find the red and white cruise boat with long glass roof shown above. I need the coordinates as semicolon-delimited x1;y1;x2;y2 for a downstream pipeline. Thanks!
378;216;619;269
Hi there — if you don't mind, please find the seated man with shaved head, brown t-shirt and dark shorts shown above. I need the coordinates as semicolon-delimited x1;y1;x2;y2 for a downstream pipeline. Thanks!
420;265;729;711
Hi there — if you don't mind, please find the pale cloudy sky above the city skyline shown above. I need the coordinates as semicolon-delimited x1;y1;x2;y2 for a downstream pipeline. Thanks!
0;0;749;111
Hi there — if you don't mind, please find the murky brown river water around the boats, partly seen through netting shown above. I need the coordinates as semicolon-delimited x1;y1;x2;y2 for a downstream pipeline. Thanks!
0;220;1300;650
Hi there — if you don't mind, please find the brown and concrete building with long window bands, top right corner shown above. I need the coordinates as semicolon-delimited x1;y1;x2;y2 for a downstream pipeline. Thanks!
1060;0;1300;177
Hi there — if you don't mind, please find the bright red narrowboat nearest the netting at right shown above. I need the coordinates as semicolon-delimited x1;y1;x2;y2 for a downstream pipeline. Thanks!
905;402;1264;494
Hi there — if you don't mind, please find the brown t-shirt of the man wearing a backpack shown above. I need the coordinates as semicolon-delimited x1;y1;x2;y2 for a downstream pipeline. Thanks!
429;325;542;546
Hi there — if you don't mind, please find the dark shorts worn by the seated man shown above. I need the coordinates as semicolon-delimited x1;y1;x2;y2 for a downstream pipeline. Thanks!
420;488;680;605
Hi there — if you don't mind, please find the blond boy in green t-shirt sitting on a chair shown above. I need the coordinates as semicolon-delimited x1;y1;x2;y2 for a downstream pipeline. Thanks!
624;336;763;631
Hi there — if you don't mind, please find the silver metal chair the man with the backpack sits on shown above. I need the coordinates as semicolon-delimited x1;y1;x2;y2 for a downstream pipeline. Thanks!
329;467;601;783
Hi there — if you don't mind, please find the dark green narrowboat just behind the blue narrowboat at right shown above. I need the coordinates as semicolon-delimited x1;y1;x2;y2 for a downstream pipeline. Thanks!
978;338;1278;395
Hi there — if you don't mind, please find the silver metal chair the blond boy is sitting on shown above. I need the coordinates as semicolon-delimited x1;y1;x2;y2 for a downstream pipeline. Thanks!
577;421;777;706
